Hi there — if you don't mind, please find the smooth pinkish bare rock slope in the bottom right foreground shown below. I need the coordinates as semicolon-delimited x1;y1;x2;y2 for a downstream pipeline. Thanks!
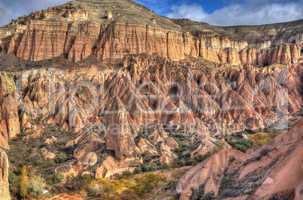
177;120;303;200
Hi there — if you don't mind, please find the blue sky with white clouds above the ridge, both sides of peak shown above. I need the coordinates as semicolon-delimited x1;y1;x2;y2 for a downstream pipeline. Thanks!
0;0;303;25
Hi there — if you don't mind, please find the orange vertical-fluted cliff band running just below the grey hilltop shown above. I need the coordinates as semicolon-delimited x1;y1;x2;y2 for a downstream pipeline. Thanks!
6;20;301;66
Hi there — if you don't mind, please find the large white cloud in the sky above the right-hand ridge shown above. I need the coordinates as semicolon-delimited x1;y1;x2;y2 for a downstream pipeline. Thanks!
168;0;303;25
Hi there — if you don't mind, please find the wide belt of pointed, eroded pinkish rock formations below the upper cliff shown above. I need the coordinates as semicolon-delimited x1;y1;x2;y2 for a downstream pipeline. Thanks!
3;55;302;173
